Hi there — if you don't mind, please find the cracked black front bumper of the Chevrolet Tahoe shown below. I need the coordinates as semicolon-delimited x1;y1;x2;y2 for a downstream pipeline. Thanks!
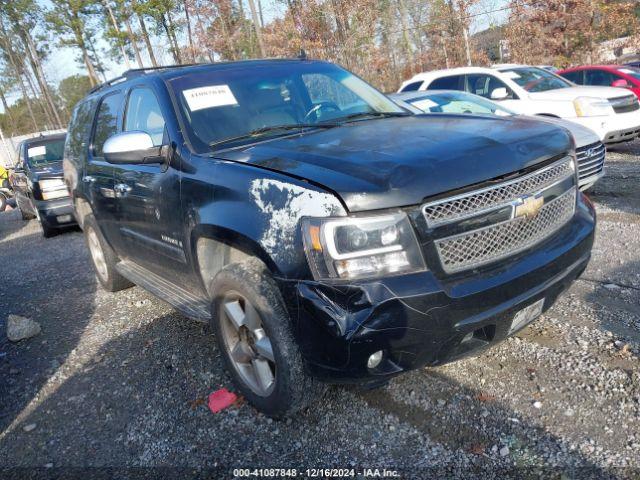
281;195;595;383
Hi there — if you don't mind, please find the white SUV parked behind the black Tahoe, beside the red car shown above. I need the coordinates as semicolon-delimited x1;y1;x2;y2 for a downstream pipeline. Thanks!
398;65;640;144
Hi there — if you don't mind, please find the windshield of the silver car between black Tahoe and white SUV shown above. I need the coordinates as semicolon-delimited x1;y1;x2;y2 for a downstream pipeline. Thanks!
406;92;515;116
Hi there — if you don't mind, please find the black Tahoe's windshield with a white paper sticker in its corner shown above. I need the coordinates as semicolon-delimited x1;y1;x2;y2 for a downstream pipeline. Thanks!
169;62;406;153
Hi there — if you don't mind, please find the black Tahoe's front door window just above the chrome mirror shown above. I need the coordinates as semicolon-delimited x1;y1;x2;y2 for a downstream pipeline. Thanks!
124;88;165;147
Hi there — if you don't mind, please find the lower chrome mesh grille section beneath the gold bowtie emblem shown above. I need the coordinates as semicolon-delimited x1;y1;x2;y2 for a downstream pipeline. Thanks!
435;187;576;273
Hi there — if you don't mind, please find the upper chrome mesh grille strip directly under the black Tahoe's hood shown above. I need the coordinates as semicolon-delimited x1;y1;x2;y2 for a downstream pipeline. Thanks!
422;157;573;228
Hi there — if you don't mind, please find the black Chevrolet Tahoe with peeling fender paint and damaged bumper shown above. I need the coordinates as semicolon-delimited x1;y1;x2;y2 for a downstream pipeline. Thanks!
64;60;595;417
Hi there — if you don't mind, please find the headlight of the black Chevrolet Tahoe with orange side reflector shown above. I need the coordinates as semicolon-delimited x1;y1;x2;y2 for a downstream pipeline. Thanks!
302;212;426;280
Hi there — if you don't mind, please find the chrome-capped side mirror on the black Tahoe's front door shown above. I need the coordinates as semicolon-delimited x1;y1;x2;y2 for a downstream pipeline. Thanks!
102;131;166;165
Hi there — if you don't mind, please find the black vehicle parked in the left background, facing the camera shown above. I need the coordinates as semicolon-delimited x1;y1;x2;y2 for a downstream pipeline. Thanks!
12;133;76;237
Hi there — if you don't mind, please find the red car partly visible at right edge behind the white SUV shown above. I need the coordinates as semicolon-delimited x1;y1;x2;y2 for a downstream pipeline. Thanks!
557;65;640;98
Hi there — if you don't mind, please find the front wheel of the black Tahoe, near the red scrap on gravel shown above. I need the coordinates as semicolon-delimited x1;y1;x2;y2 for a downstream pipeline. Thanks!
210;259;324;418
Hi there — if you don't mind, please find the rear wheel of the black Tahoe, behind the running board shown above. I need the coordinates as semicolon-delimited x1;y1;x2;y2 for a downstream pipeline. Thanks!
84;215;133;292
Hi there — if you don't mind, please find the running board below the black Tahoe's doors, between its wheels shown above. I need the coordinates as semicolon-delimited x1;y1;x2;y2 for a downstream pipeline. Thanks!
116;260;211;322
